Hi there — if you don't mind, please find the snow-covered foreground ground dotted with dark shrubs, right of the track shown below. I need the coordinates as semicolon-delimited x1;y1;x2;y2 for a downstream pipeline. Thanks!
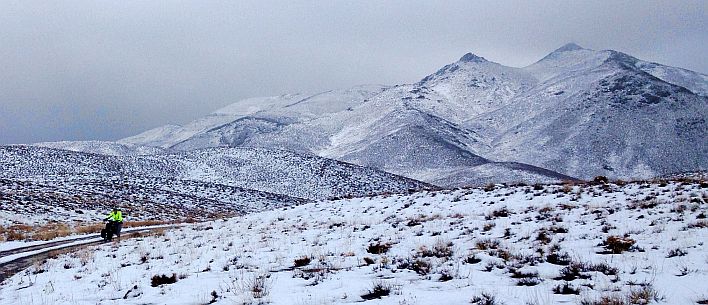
0;182;708;304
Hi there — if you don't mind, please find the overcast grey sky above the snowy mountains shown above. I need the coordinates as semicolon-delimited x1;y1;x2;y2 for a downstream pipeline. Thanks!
0;0;708;144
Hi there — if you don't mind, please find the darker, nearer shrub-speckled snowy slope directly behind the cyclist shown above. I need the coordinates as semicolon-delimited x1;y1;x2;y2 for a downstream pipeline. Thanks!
0;175;308;227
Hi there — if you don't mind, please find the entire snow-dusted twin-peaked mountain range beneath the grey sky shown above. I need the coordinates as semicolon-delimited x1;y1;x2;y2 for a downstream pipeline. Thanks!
108;43;708;186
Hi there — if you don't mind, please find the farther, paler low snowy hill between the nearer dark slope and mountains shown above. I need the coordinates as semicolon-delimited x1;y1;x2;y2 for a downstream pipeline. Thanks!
0;146;430;199
